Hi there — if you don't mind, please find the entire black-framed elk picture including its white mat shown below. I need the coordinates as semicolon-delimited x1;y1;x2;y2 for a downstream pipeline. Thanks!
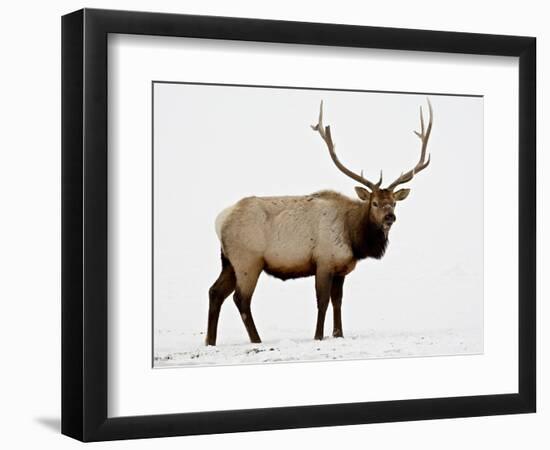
62;9;536;441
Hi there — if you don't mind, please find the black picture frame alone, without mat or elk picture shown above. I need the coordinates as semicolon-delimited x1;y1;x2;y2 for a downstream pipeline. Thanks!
62;9;536;441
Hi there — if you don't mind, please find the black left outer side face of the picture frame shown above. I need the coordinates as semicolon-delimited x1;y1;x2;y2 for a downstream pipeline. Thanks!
61;10;85;440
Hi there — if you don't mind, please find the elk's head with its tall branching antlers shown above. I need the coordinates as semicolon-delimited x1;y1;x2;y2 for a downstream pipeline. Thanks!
311;99;433;237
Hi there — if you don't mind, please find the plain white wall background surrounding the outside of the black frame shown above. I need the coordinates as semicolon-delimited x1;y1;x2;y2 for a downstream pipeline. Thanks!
0;1;550;449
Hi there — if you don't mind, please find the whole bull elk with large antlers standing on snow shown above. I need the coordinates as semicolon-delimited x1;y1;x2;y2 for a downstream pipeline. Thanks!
206;100;433;345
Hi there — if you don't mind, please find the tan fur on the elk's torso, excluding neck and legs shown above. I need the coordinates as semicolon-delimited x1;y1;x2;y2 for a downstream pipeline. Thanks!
216;191;362;278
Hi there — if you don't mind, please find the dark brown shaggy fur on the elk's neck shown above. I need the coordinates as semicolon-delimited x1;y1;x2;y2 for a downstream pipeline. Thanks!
348;207;388;259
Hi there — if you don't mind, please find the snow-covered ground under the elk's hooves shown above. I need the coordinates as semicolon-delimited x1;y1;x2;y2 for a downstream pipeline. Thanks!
154;329;483;367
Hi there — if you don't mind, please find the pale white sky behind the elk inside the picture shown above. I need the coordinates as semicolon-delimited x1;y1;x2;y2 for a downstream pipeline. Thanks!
154;83;483;337
